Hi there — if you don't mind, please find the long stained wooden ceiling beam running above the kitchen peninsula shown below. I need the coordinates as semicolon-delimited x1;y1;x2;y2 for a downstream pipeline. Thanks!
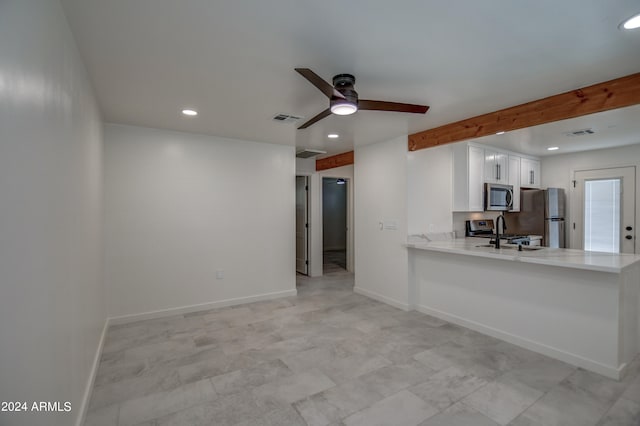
409;73;640;151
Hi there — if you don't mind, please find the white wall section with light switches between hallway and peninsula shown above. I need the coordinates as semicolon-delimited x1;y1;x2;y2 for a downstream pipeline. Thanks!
354;136;409;309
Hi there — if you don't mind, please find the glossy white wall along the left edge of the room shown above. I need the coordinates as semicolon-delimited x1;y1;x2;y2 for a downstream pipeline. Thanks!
0;0;106;426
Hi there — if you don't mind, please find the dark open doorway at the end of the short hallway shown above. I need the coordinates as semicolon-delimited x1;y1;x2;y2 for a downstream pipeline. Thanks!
322;177;349;273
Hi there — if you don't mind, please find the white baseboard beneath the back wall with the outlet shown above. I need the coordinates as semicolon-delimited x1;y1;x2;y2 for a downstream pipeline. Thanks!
109;289;298;325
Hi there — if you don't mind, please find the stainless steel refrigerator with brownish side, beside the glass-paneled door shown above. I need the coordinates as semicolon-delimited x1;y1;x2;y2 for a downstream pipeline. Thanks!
505;188;565;247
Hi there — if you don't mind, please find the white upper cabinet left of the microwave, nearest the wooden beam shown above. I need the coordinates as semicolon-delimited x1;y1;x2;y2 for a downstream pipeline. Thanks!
453;143;485;212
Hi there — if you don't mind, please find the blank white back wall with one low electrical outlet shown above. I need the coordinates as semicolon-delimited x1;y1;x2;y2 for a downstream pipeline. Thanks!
105;125;296;318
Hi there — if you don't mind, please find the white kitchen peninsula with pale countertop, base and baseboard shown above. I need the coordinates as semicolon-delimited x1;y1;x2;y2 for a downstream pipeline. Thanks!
407;238;640;379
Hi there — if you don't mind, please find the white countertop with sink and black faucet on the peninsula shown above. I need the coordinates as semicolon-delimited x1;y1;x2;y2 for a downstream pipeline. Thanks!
405;238;640;273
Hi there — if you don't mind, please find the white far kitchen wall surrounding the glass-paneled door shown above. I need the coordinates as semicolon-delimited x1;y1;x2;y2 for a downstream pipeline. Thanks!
541;144;640;251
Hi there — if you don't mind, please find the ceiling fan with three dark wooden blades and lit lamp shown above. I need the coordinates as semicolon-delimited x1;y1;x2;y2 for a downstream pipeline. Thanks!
295;68;429;129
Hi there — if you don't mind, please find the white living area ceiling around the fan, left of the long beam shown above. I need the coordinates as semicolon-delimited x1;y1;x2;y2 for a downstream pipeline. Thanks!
62;0;640;157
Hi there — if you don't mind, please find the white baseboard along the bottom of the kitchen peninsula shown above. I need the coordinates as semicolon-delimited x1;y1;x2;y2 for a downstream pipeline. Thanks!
415;305;626;380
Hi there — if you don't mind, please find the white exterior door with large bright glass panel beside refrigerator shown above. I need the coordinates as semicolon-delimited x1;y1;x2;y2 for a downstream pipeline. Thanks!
572;166;636;253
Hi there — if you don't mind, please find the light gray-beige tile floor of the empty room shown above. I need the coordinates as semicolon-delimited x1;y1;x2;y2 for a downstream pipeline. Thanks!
86;271;640;426
